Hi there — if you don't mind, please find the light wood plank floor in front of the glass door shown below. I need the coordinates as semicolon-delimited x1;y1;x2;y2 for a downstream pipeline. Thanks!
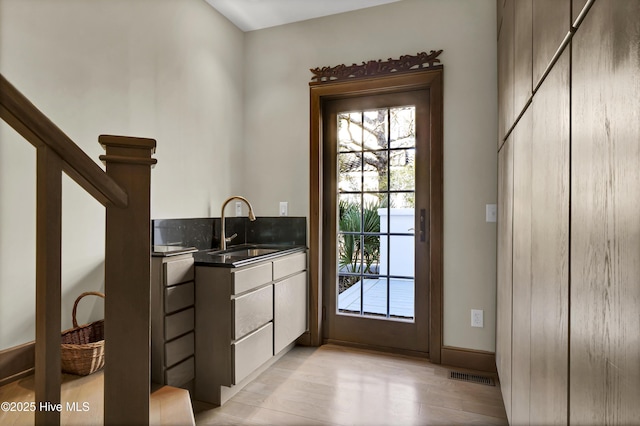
194;345;507;426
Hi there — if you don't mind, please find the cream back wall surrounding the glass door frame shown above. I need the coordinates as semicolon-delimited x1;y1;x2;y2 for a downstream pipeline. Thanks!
243;0;497;351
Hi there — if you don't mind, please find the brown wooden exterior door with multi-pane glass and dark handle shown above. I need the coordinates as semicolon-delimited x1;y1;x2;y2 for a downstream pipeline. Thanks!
322;90;430;354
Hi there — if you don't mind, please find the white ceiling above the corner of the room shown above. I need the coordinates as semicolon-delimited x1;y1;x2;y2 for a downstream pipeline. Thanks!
206;0;400;31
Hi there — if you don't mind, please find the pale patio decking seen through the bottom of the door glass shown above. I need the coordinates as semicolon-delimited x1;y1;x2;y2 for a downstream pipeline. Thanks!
338;278;414;319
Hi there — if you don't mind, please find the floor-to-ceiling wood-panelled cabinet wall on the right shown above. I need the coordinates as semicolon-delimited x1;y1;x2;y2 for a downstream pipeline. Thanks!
496;0;640;424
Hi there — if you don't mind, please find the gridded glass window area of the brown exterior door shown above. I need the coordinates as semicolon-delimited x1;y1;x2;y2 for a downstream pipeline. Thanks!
336;106;415;320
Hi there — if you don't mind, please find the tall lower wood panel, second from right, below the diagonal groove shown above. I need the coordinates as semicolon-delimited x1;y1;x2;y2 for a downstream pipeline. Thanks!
530;50;570;424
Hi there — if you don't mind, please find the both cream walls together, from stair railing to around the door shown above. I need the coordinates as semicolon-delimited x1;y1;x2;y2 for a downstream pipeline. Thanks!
0;0;497;351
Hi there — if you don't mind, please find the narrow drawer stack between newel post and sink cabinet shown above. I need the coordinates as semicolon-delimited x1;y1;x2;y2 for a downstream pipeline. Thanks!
151;254;195;390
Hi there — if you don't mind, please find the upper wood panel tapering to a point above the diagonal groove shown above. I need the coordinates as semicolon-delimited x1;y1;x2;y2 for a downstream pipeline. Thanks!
533;0;571;86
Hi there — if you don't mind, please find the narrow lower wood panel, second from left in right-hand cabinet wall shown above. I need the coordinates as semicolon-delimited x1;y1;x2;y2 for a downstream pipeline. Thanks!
511;108;533;425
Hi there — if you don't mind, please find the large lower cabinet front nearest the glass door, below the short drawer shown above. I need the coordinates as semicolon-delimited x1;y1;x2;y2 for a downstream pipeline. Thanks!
273;271;308;354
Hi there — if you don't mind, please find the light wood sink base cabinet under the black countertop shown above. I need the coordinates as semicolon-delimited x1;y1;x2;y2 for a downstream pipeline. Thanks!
194;252;308;405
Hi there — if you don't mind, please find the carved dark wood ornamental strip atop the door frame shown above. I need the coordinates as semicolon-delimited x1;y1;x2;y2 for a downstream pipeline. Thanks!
310;50;442;84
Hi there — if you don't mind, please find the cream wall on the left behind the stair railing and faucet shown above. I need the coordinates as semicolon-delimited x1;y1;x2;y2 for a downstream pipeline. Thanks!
0;0;244;350
